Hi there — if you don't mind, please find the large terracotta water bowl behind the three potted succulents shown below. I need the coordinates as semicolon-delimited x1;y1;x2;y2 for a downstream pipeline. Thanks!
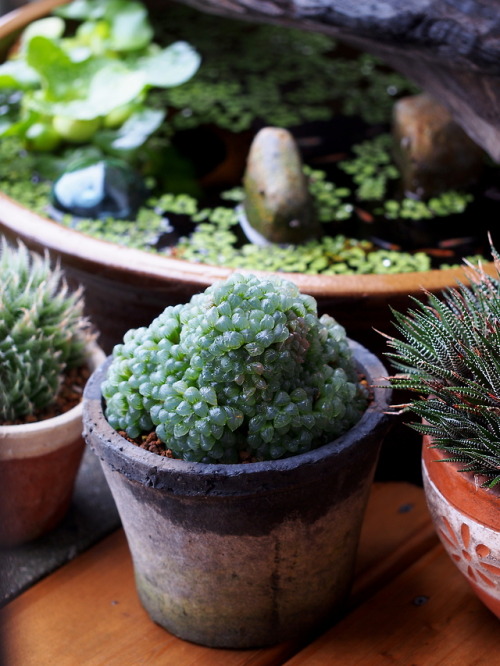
0;0;492;352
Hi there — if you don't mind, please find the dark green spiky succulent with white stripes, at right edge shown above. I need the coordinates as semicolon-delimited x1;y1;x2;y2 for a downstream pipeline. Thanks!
388;250;500;487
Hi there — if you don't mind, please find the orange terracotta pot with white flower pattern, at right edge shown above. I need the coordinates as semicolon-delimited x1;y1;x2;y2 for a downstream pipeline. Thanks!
422;437;500;619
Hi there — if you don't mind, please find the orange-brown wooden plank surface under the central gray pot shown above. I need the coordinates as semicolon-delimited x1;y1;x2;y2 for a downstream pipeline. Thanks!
0;483;500;666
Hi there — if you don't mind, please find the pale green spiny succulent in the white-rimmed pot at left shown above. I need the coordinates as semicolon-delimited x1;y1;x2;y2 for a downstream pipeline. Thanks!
0;239;86;422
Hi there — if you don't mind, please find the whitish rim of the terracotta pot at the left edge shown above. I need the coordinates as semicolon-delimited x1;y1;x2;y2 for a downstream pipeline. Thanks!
0;340;105;460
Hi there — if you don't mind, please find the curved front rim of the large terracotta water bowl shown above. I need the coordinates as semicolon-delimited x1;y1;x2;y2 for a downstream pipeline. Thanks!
0;192;488;299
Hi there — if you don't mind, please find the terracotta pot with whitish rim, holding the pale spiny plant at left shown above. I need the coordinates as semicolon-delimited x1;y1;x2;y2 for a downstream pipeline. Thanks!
0;343;104;547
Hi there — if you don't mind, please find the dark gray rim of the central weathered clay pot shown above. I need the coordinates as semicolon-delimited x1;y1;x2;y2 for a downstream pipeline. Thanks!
83;340;391;494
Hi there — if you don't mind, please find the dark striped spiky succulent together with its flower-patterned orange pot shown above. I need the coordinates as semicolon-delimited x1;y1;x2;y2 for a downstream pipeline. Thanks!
388;249;500;618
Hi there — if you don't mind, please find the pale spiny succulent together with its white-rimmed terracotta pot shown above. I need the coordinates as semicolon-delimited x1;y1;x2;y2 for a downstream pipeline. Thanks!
0;240;104;546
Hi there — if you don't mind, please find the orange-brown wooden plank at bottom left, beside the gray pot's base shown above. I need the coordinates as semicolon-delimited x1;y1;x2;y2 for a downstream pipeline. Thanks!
3;530;289;666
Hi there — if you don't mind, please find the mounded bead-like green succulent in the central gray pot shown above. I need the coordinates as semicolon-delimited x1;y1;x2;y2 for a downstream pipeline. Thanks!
103;274;367;463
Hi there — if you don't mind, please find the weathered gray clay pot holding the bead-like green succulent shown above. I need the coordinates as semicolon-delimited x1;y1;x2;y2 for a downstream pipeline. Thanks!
84;343;390;648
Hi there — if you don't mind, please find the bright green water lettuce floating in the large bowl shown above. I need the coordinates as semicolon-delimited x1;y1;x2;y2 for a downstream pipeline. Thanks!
0;0;200;153
